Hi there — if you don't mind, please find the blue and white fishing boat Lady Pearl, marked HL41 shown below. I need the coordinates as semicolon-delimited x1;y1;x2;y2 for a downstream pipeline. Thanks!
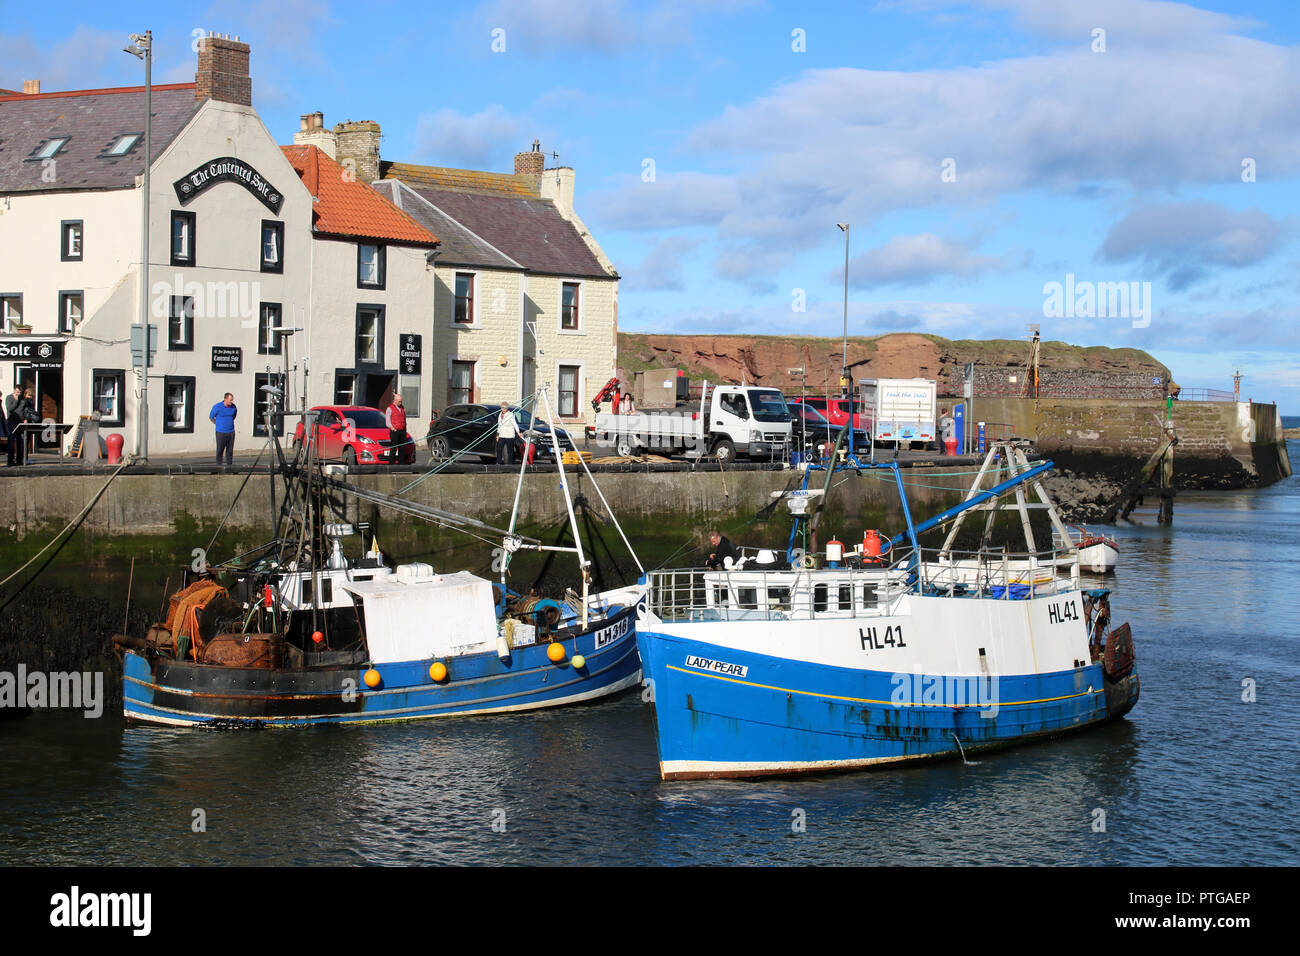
637;436;1139;780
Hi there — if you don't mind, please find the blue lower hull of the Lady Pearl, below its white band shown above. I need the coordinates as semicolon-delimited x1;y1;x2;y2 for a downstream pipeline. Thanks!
637;622;1139;780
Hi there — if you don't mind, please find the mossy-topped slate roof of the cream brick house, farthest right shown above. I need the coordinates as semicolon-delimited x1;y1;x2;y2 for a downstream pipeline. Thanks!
380;163;611;278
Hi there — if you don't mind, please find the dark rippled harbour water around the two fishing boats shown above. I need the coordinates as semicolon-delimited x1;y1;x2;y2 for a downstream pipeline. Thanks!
0;441;1300;865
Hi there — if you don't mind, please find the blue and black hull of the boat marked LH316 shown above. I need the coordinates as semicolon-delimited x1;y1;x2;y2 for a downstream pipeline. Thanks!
124;607;641;727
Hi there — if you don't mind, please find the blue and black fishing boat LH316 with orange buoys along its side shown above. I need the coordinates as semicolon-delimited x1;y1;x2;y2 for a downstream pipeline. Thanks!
114;389;644;727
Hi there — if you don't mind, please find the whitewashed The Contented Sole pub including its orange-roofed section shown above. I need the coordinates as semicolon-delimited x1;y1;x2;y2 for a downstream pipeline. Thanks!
0;36;437;455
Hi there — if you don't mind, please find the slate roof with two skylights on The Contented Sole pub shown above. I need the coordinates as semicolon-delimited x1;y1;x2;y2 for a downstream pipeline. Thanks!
0;83;200;193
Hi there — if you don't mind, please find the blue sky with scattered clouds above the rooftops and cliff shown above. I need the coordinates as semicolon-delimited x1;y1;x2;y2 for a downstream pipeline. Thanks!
0;0;1300;415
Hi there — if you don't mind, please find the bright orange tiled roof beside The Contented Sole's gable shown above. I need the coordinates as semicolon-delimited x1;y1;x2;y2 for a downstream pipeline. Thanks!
280;146;438;246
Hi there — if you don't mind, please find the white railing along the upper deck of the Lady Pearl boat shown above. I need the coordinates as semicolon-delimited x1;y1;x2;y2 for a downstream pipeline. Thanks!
647;548;1079;620
